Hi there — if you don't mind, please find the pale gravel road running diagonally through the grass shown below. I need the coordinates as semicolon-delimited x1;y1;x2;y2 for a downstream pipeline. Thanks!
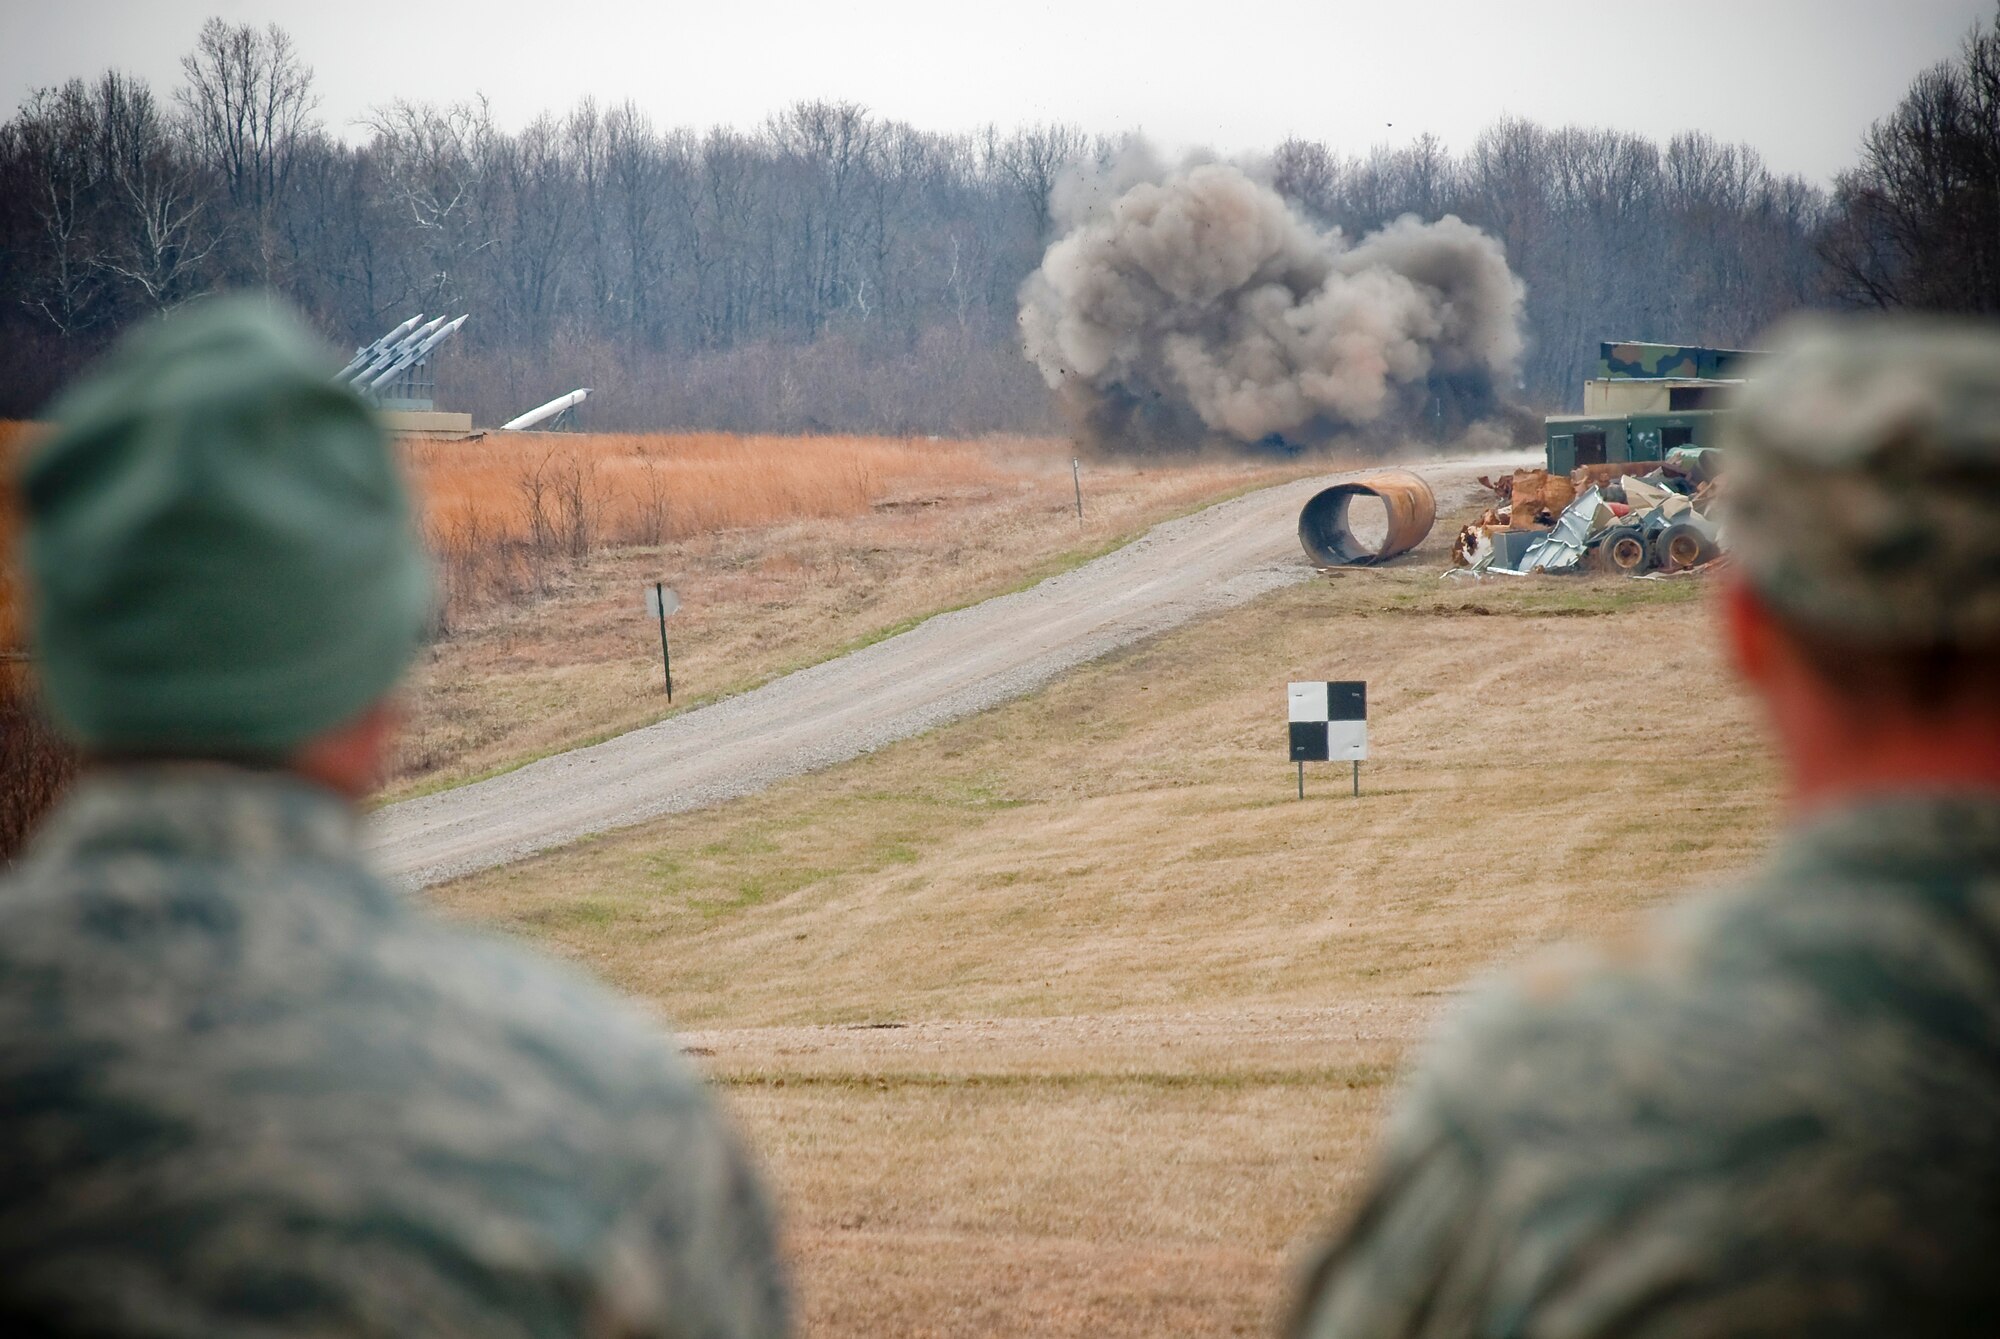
370;454;1534;887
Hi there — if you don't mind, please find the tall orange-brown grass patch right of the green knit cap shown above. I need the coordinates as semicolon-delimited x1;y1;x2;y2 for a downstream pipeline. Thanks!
402;432;1010;632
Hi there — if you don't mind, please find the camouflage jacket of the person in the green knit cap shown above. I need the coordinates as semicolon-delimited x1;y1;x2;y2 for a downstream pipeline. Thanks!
0;771;788;1339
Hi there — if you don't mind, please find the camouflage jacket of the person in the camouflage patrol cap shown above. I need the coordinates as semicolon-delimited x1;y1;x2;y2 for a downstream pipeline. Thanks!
1298;799;2000;1335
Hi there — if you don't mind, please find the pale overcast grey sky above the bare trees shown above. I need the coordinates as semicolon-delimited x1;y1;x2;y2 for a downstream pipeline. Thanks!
0;0;1994;182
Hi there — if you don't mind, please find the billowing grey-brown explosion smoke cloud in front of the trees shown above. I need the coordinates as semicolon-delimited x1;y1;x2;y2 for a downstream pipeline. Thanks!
1020;152;1524;446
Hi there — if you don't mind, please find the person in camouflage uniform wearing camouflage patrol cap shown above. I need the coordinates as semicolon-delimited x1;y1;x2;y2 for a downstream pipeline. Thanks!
1294;322;2000;1339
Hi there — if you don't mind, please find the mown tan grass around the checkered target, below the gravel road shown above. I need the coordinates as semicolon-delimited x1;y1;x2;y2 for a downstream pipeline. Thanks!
432;522;1772;1337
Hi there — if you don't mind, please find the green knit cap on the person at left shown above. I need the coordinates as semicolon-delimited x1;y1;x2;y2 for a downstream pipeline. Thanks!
22;298;432;759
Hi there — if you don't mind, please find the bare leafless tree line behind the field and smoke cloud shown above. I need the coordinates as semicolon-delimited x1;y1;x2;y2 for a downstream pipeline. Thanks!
0;20;2000;432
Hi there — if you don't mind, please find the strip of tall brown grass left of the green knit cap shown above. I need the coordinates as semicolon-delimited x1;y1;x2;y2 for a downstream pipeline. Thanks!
0;420;76;869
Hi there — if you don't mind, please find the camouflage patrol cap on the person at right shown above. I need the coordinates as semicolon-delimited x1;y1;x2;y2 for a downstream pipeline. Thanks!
1724;318;2000;646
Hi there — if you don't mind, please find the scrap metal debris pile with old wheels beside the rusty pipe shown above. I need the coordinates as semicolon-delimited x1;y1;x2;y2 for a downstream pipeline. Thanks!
1452;448;1722;576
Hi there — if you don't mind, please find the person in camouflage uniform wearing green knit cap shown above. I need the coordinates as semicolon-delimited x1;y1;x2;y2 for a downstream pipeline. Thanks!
0;300;786;1339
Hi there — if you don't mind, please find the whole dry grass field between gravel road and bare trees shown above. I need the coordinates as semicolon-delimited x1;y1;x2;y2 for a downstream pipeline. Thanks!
386;434;1332;797
